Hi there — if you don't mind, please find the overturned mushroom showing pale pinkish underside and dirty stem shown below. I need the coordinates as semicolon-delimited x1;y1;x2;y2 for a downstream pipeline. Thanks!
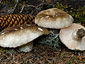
59;23;85;51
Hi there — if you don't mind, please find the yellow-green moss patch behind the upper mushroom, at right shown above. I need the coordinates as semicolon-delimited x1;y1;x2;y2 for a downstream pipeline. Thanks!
53;2;85;26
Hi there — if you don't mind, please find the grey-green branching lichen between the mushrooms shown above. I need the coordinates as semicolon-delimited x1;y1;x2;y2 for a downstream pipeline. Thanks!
36;30;61;49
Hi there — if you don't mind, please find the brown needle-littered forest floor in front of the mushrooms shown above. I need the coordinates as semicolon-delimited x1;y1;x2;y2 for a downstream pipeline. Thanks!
0;44;85;64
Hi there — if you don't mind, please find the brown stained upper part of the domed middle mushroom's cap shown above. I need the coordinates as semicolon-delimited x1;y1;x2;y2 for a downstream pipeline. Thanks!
37;8;69;21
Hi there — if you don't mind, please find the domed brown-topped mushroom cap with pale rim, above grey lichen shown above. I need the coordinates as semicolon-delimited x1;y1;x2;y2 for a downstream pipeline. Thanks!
35;8;73;29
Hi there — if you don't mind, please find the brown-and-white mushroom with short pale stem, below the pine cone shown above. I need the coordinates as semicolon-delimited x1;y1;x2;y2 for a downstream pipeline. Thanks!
0;24;49;52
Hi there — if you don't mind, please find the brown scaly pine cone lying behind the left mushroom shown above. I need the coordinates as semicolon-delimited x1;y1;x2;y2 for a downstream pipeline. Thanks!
0;14;34;30
